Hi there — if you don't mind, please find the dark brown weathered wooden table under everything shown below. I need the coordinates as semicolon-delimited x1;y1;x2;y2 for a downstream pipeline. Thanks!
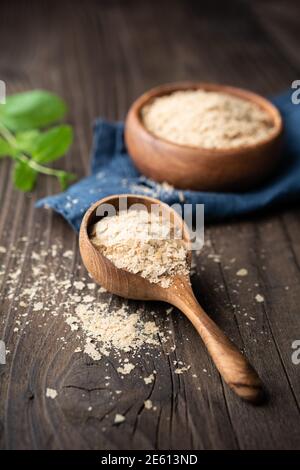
0;0;300;449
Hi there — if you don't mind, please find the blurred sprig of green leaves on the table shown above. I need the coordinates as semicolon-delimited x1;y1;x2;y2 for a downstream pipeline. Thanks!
0;90;75;191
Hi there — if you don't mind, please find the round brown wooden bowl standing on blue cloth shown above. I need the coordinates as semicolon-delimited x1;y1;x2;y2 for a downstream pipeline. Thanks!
125;82;283;191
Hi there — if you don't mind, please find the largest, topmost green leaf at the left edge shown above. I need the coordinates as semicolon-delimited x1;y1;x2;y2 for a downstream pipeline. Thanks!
0;90;66;132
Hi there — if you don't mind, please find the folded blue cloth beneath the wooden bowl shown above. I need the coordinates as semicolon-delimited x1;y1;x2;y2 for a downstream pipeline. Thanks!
36;91;300;231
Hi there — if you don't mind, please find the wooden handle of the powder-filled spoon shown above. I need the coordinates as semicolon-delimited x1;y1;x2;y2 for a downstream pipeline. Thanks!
172;289;264;403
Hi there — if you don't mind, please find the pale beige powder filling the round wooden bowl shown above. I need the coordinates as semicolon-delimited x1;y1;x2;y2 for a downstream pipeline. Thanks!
142;90;274;149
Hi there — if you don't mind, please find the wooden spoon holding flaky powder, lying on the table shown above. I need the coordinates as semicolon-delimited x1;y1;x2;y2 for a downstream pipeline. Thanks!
79;194;264;403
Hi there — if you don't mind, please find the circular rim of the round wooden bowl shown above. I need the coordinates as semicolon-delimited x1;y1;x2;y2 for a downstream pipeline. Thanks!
125;81;283;156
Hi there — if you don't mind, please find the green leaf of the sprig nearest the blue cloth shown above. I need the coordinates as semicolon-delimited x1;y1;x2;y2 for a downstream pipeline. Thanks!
30;126;73;164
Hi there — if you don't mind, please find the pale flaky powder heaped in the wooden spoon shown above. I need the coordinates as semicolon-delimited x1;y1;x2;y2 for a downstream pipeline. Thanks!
91;210;189;288
